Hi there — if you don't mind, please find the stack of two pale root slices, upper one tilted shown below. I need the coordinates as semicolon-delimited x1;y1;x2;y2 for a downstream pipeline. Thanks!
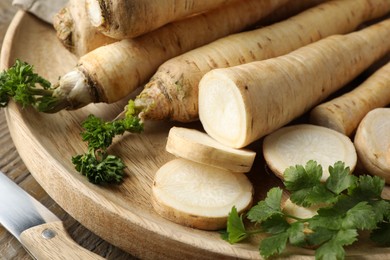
152;127;256;230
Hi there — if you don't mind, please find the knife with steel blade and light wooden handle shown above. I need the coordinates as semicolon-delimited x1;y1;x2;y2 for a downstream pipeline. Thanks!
0;171;103;260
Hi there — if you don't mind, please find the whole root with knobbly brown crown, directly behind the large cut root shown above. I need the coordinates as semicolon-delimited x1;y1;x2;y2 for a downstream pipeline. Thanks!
135;0;390;122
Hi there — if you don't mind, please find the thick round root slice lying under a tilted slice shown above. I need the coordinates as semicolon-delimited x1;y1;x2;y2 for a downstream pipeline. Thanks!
152;158;253;230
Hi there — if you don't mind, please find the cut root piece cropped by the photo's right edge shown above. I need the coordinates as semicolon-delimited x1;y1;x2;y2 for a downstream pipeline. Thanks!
354;108;390;184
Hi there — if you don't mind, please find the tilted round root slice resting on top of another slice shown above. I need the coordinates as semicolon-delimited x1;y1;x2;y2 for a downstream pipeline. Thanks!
166;127;256;172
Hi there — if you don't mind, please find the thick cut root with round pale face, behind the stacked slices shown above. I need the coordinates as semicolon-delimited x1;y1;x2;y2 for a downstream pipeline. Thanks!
199;19;390;148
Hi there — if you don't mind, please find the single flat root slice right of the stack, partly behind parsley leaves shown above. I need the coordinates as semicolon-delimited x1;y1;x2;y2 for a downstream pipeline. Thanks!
263;124;357;181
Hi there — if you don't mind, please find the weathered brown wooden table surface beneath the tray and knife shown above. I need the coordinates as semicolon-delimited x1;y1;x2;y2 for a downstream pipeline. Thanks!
0;0;134;259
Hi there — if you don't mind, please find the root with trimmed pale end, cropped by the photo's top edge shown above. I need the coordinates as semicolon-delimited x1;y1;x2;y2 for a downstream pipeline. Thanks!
86;0;244;40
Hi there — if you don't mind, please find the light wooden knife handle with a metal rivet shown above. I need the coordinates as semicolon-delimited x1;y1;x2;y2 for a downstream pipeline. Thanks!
20;221;104;260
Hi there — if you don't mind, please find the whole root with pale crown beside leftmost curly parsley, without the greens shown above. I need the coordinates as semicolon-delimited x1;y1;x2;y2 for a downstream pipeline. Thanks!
53;0;287;109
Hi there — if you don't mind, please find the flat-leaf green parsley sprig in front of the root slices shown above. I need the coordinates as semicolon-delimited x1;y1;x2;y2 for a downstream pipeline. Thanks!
222;161;390;259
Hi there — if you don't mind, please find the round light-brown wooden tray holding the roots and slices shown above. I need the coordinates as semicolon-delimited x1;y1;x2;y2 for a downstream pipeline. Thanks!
1;11;390;259
